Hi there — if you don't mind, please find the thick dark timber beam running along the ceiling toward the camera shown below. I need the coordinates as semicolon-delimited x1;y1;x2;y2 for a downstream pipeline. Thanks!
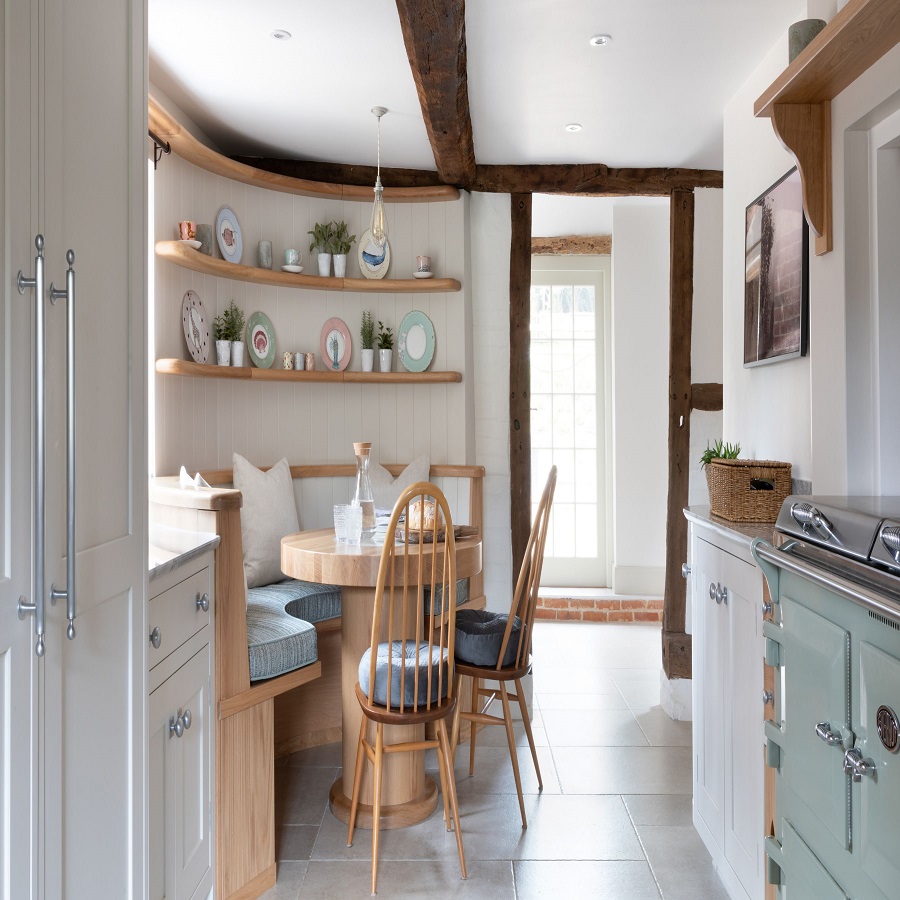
397;0;475;185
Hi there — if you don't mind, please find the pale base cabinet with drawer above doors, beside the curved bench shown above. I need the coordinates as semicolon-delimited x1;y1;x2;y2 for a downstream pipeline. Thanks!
147;553;215;900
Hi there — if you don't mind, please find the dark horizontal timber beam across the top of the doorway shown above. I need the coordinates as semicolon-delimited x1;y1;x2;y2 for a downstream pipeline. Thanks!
472;164;722;197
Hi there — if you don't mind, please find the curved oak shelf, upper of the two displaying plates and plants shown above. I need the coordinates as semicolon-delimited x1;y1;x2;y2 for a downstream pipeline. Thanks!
156;241;462;294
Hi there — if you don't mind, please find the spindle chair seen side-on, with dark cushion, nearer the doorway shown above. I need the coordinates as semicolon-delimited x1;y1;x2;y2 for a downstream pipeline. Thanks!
453;466;556;828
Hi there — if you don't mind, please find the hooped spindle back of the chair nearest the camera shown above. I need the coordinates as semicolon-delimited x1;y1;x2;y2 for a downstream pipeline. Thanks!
368;481;456;713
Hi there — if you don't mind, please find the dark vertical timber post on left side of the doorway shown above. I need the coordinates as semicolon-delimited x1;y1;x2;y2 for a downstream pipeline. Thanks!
509;194;532;586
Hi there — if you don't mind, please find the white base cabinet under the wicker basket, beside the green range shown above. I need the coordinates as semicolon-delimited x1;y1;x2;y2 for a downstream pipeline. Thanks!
690;519;765;900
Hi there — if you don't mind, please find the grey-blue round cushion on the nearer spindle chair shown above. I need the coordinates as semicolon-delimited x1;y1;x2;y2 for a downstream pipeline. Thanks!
359;641;449;709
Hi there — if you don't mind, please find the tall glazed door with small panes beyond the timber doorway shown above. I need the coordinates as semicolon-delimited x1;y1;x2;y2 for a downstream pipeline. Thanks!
530;256;612;589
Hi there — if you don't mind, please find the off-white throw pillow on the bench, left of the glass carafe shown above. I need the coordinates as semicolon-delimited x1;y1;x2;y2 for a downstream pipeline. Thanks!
233;453;300;587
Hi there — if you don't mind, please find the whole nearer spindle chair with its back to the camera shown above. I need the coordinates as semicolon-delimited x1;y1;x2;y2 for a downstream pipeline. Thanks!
347;481;466;894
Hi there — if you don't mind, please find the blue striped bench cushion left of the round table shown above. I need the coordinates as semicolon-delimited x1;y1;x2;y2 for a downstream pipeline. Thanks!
247;579;341;681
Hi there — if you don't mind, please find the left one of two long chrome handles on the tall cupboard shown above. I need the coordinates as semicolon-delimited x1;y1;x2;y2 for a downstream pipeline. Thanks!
16;234;44;656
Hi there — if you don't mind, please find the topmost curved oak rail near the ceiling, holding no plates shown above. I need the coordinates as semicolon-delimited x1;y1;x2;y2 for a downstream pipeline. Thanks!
147;96;459;203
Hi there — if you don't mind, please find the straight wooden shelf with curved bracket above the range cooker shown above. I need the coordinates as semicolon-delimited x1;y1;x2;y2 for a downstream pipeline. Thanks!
753;0;900;256
